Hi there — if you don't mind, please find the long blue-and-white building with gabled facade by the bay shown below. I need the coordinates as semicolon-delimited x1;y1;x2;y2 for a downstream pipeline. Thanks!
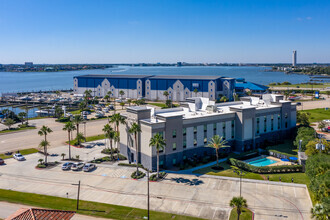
74;75;235;101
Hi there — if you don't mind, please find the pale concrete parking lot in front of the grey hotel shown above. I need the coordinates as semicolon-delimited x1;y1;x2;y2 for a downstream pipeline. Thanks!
0;151;312;220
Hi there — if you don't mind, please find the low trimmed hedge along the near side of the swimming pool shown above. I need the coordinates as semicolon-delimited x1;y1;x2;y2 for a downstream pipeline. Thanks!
229;158;302;173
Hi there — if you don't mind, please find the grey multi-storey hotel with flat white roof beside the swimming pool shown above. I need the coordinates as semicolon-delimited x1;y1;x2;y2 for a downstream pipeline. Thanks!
119;94;296;170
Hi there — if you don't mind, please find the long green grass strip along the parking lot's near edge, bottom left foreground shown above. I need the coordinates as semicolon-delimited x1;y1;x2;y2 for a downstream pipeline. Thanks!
0;189;199;220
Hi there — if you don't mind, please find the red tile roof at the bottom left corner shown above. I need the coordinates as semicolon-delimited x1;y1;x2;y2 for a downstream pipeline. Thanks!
6;208;76;220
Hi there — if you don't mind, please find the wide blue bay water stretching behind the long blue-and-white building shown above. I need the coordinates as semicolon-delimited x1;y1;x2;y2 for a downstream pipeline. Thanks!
0;66;309;93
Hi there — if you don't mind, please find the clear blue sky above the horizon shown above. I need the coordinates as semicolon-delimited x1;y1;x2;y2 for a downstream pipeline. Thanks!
0;0;330;64
